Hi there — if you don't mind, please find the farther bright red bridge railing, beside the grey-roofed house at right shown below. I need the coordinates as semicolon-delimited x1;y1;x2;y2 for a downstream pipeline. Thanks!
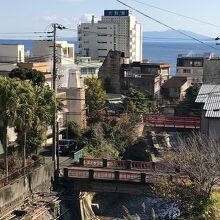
144;115;200;129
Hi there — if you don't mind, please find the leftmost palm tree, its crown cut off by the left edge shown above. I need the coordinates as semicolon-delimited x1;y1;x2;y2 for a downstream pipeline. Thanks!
0;77;19;177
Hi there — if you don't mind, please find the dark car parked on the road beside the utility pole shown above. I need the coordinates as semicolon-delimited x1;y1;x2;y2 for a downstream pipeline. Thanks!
59;139;77;155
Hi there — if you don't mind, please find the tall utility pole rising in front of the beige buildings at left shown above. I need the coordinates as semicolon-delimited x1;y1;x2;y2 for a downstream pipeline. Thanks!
52;23;58;174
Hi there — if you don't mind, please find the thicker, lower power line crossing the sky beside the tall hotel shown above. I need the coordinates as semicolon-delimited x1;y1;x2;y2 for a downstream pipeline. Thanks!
115;0;220;51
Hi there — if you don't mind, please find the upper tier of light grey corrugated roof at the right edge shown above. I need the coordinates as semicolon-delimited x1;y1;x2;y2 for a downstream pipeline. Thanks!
195;84;220;103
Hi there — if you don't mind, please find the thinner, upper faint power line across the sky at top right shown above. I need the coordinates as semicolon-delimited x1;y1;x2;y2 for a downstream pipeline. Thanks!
130;0;220;28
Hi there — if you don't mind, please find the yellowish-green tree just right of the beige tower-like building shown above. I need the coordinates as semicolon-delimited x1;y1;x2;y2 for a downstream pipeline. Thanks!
85;78;106;113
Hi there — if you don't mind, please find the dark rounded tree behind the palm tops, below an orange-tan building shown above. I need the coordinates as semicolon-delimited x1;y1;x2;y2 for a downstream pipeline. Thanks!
9;68;46;85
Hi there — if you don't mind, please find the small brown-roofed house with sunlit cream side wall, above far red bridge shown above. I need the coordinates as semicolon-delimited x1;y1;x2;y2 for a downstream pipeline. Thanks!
161;76;192;100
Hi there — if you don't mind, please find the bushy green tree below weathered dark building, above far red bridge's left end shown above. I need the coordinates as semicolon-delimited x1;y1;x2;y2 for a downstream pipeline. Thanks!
123;89;156;113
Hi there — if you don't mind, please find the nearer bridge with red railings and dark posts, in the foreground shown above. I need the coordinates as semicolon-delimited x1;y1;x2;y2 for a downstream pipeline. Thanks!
63;158;189;192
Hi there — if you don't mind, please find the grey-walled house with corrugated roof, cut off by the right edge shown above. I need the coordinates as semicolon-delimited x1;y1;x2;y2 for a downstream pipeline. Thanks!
195;84;220;140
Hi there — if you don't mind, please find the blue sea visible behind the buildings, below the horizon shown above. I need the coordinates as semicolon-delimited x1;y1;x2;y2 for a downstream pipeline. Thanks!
0;39;220;75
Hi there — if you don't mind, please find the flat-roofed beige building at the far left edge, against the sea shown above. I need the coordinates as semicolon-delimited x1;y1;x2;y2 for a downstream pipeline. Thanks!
0;44;24;63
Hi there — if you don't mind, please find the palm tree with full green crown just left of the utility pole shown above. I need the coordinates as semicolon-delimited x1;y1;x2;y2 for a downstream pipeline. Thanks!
16;85;56;159
